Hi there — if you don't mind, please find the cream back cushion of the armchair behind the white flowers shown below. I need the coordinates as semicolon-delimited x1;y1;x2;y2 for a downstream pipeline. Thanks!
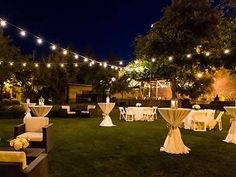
25;117;49;132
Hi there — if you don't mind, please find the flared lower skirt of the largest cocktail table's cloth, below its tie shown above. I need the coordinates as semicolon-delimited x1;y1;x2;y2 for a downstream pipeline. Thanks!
160;126;190;154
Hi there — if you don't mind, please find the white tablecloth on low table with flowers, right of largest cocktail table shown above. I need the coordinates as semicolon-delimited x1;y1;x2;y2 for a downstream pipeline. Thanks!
184;109;215;129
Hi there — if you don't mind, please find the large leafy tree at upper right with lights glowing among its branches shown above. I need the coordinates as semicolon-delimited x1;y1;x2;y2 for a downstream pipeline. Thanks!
135;0;235;98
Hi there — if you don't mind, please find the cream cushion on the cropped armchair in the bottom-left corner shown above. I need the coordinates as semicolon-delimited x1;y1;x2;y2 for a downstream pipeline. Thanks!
0;151;27;169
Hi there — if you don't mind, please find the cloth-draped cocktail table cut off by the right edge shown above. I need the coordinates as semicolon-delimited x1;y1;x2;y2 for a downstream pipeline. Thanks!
224;106;236;144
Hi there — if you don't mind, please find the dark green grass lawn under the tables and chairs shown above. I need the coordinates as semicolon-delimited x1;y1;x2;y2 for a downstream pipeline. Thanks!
0;112;236;177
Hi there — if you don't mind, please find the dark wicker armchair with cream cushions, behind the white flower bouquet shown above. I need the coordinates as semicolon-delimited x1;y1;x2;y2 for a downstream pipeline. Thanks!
14;117;53;152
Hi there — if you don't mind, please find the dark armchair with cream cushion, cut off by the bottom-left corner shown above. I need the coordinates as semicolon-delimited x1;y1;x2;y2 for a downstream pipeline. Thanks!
0;151;48;177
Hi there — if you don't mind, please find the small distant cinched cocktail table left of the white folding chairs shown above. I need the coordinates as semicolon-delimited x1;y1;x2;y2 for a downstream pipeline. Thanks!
98;103;115;127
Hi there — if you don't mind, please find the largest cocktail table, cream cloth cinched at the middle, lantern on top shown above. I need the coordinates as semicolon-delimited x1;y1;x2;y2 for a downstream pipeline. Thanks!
158;108;191;154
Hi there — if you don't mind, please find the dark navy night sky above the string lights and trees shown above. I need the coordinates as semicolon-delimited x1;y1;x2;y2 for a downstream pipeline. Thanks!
0;0;171;60
